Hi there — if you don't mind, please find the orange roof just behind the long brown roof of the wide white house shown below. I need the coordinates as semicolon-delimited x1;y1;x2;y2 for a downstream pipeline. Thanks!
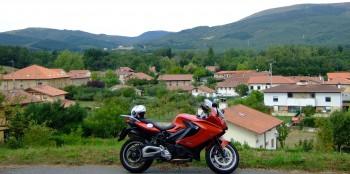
248;76;296;84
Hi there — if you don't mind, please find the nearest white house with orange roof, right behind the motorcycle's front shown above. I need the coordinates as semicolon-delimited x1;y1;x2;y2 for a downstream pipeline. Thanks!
224;105;282;150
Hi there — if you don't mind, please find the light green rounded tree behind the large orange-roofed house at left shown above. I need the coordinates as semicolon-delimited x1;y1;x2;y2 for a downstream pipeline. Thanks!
54;50;84;71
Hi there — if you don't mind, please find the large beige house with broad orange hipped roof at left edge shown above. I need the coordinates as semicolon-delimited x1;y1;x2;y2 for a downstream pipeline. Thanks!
0;65;70;90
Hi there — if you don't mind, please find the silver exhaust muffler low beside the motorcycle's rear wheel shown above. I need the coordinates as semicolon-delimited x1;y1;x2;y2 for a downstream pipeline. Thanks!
142;146;171;160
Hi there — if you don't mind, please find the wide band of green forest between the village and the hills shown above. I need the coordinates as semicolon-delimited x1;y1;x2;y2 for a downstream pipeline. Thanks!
0;45;350;75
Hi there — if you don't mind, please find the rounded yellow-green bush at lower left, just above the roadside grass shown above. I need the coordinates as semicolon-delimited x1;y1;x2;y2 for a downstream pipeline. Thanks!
23;122;55;147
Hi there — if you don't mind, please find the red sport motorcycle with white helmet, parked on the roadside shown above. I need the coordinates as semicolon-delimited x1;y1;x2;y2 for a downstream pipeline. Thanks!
119;100;239;173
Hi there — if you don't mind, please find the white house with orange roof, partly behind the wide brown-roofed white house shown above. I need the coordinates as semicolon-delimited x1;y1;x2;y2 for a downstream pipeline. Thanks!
248;75;296;91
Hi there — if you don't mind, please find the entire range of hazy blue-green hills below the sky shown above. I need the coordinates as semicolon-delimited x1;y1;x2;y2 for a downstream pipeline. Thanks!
0;3;350;51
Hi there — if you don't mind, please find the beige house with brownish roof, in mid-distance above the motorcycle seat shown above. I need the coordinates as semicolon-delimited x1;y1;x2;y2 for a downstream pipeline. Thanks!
158;74;193;91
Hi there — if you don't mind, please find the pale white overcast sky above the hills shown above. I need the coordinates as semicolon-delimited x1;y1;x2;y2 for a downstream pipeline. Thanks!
0;0;345;36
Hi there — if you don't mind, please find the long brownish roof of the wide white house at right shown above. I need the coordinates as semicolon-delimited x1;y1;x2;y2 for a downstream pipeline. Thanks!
264;85;342;93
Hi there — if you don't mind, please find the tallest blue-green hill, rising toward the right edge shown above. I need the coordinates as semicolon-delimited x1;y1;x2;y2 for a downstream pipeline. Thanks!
149;3;350;50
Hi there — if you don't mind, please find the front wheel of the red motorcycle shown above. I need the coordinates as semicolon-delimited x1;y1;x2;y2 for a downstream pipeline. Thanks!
205;143;239;174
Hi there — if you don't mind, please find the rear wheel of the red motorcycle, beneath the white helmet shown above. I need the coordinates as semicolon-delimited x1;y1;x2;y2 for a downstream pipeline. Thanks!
120;139;153;173
